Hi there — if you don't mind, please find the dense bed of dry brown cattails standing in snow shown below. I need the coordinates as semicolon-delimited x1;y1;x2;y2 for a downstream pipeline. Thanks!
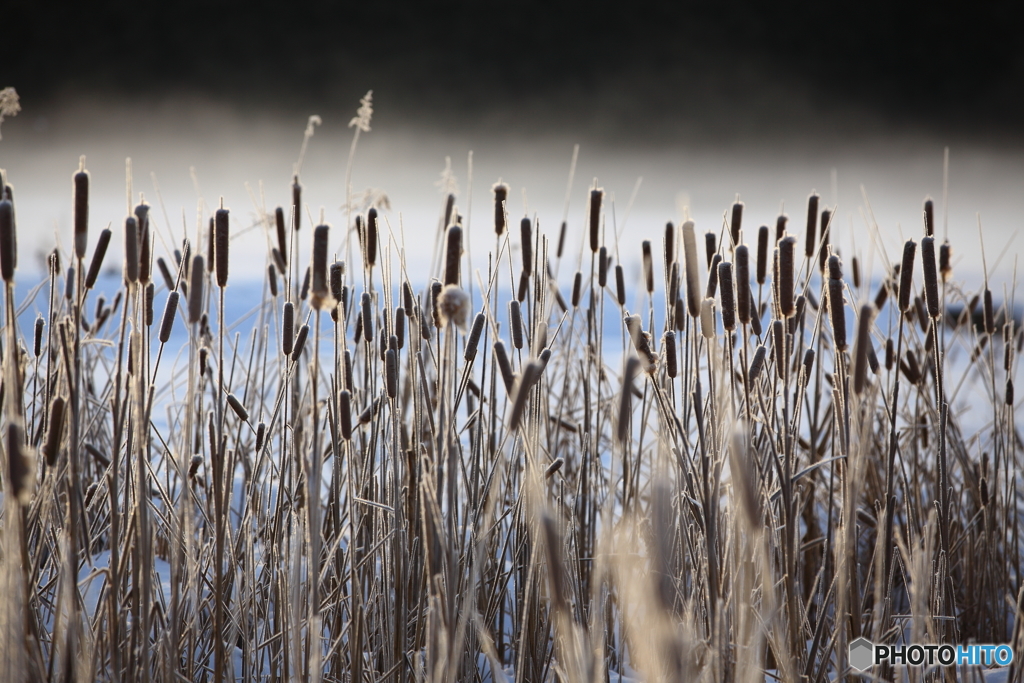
0;101;1024;683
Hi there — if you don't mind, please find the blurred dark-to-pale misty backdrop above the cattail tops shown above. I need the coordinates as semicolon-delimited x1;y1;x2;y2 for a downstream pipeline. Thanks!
0;0;1024;287
